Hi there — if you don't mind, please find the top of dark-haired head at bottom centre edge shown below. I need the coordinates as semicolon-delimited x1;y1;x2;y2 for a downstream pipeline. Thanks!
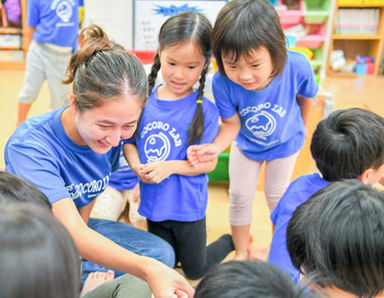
194;261;312;298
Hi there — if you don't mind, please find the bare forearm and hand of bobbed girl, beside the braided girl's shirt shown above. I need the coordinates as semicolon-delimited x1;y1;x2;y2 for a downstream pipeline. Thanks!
187;113;241;166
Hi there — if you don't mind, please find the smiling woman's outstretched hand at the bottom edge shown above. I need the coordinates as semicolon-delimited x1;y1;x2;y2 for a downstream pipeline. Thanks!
146;260;194;298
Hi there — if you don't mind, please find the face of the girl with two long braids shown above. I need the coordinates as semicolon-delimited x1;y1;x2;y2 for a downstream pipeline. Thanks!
159;41;206;99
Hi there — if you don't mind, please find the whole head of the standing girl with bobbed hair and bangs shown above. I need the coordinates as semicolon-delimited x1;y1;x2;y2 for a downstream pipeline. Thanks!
212;0;287;89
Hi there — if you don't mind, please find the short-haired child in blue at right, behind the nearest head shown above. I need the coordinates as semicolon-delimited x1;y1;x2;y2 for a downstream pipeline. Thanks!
269;108;384;281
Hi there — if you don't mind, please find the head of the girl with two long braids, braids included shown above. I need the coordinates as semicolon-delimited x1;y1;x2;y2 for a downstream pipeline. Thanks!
148;11;212;144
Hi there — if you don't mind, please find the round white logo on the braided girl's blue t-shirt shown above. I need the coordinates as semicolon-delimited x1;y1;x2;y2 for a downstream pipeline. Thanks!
144;132;171;162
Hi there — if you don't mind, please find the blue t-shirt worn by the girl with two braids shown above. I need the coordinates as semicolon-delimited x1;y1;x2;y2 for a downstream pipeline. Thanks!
130;88;219;221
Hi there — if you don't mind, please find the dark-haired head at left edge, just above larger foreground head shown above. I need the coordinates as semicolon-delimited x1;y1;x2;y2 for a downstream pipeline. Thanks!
0;171;51;210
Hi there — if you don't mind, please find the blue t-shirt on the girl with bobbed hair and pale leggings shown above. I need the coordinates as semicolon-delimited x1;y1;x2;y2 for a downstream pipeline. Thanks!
212;51;319;161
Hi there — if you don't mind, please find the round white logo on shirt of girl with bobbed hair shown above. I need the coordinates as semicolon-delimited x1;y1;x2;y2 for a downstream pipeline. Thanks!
245;111;276;140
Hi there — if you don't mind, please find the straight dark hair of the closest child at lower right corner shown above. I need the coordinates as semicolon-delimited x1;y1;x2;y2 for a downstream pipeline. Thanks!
287;179;384;297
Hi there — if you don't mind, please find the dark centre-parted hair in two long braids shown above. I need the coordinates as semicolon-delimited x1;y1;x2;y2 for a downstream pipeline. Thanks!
148;11;212;144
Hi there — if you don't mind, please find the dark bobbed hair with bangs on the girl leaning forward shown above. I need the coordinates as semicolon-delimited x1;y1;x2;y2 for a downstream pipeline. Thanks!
212;0;287;77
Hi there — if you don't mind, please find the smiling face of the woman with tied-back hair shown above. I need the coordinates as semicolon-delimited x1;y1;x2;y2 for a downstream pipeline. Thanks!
75;95;142;154
